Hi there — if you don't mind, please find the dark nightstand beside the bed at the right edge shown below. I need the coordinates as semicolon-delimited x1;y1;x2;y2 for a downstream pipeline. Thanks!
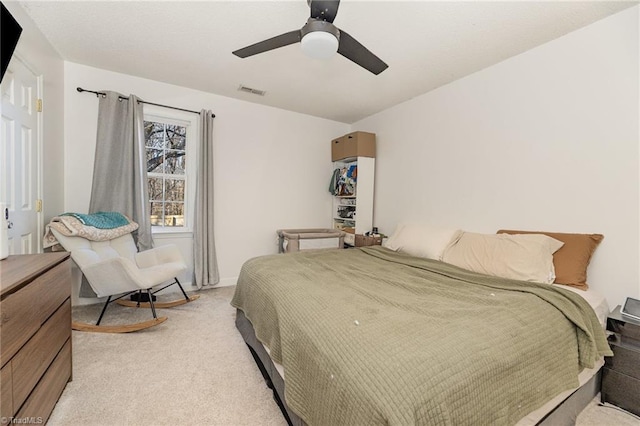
601;306;640;415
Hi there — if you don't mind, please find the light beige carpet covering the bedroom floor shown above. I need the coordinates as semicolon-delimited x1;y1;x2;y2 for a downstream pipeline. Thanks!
48;287;640;426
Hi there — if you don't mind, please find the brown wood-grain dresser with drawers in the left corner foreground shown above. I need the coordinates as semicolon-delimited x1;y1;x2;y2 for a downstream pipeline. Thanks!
0;252;71;424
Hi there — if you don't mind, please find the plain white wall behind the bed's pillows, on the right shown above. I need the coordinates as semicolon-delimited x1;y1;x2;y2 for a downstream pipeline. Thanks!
352;7;640;308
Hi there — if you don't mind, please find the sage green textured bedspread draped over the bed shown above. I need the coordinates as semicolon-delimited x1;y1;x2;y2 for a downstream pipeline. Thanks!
231;246;611;426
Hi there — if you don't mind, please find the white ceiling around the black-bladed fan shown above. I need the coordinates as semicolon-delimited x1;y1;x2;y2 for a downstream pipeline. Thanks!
19;0;638;123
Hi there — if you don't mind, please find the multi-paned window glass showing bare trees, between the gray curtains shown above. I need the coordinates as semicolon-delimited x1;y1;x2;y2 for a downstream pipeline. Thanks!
144;121;187;227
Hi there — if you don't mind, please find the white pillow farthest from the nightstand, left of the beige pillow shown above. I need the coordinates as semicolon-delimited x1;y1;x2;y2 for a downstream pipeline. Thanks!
382;223;462;260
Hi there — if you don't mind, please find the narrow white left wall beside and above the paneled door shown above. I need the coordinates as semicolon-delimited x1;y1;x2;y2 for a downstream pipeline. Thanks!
3;1;64;223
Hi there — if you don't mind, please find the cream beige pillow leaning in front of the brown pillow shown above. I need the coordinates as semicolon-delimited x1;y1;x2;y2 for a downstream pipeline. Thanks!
442;232;563;284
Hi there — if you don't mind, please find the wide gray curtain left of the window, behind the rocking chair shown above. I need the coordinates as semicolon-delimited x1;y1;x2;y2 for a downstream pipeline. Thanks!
89;91;153;251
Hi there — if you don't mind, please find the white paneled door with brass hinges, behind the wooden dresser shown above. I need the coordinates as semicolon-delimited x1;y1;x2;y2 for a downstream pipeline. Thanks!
0;56;42;254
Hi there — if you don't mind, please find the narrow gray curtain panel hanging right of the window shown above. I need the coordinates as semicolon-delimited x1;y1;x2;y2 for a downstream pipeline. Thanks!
193;109;220;289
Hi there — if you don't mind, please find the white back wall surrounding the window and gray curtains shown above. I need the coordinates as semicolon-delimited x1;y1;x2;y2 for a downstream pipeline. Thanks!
64;62;350;303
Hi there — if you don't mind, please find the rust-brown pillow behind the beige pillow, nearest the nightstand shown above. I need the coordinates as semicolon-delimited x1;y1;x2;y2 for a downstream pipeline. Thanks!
497;229;604;290
